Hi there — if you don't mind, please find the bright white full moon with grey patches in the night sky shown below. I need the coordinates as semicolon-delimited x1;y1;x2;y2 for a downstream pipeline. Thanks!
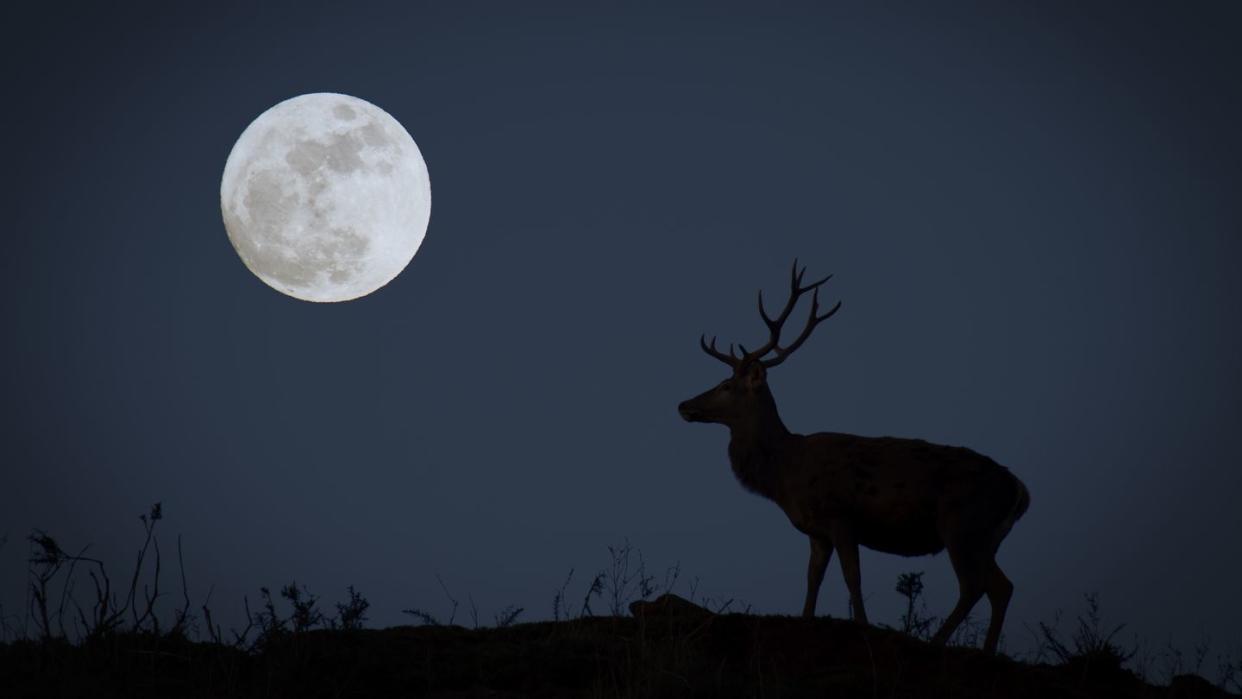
220;93;431;302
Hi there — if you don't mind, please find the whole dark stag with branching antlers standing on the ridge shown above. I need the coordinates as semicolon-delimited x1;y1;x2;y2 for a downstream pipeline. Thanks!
678;259;1030;653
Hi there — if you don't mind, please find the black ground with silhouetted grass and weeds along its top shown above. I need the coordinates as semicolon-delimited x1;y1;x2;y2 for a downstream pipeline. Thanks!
0;504;1242;698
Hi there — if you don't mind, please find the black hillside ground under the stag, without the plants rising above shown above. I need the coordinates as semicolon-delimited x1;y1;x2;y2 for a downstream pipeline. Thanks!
0;613;1228;699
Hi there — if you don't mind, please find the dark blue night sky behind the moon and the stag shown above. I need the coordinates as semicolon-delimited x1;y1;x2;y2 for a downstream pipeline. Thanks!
0;2;1242;651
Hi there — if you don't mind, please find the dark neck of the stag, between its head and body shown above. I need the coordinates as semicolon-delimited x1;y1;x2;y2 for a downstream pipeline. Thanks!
729;389;797;500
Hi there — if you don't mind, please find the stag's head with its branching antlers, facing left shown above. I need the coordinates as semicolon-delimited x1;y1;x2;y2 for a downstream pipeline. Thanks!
677;259;841;426
